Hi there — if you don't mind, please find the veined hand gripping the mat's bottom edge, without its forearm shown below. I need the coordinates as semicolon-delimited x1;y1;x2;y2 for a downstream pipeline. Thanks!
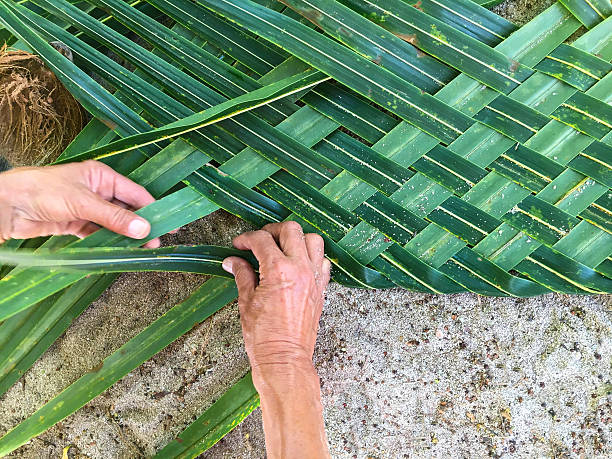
224;222;331;378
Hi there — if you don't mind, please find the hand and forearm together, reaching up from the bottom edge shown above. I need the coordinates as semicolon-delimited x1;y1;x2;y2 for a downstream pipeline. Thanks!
223;222;331;459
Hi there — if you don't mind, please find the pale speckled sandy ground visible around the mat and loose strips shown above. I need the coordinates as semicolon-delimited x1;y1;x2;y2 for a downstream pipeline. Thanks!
0;0;612;459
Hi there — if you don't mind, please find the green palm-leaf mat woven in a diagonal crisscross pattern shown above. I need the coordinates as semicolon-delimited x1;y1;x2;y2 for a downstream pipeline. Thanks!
2;0;612;296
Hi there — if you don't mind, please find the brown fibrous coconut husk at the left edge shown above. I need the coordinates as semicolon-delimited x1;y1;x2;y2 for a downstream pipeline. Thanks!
0;45;84;166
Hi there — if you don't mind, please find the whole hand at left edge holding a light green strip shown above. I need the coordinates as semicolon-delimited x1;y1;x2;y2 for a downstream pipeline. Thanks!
0;161;159;247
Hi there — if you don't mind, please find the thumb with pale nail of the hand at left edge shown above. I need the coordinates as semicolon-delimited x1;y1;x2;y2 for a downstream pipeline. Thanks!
75;193;151;239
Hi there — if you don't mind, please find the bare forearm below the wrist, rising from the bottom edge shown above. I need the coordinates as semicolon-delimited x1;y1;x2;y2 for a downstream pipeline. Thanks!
253;367;329;459
